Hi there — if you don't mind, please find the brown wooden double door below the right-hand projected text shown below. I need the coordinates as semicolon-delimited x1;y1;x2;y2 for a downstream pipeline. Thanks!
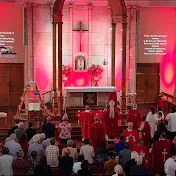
136;63;160;103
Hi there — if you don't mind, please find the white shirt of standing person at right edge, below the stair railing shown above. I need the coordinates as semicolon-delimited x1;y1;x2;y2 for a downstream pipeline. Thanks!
166;112;176;132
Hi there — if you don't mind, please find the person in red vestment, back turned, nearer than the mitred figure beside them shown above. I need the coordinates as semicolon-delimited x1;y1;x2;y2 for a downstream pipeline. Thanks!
90;116;105;150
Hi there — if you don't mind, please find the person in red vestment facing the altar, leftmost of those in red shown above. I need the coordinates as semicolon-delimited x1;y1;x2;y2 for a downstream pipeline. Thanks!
78;105;94;139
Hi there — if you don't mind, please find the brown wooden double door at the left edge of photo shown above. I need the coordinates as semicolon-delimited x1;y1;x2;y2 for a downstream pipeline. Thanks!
0;64;24;106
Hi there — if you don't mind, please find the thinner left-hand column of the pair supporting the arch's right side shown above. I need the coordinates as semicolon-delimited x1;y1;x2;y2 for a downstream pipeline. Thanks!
111;23;117;86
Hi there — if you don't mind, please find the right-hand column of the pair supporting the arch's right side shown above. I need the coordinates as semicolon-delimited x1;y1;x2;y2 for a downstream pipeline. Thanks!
121;16;127;116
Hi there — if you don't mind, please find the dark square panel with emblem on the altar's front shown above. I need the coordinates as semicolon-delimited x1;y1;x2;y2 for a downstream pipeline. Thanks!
83;92;97;106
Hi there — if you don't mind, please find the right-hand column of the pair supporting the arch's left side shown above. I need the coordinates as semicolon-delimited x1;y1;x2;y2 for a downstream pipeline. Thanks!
58;18;63;113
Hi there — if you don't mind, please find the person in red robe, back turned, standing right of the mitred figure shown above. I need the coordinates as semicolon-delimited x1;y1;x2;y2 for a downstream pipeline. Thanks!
127;105;142;130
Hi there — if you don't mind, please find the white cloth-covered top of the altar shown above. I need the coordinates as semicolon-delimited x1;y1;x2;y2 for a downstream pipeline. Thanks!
65;86;116;93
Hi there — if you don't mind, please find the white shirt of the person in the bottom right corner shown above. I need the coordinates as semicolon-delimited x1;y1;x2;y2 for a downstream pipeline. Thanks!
164;158;176;176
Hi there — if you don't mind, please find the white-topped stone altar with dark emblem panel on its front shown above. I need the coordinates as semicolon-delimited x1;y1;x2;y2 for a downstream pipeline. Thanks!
65;86;116;107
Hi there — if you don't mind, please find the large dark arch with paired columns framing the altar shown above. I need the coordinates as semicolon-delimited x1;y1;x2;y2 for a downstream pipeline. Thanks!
53;0;127;116
